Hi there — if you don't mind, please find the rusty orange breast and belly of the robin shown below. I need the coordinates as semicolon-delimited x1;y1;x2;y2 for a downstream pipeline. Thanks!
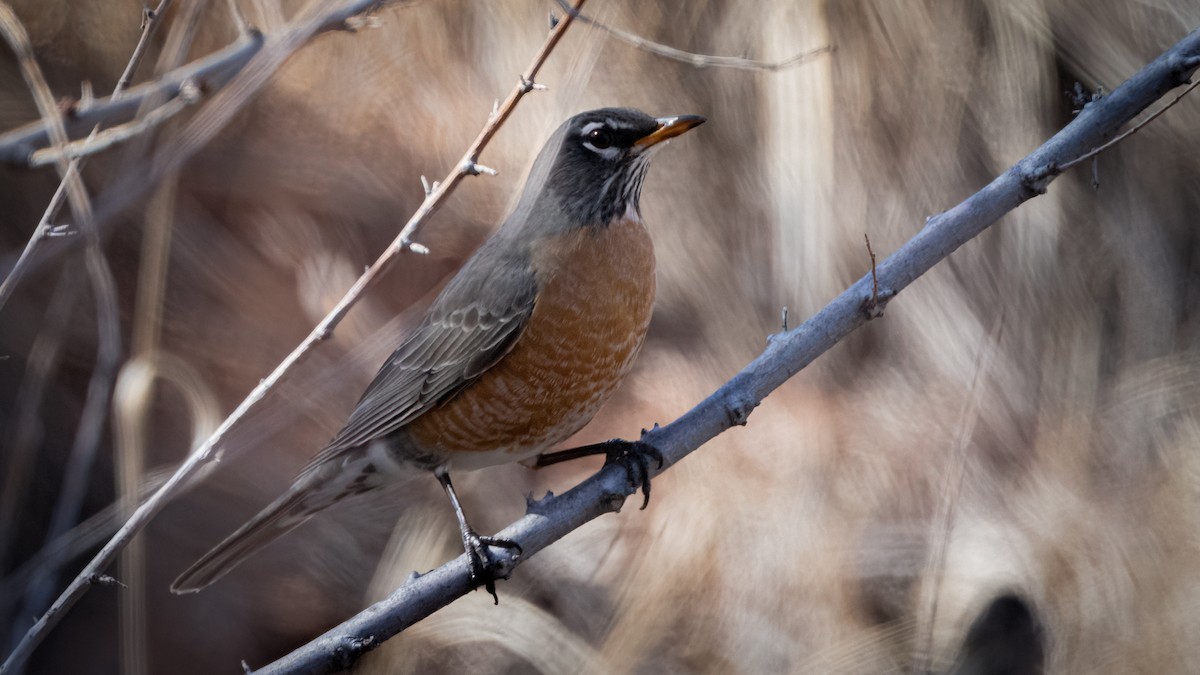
407;219;654;468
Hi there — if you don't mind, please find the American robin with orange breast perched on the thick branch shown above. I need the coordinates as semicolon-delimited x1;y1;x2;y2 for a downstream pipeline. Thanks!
170;108;704;596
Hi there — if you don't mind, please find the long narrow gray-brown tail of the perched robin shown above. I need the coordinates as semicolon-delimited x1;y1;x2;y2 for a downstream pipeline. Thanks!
170;480;328;593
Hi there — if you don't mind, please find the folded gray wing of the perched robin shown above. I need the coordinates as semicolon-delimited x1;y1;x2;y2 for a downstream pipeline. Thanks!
301;245;538;476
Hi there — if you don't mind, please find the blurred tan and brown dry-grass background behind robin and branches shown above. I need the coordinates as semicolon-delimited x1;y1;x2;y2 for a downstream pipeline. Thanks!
0;0;1200;674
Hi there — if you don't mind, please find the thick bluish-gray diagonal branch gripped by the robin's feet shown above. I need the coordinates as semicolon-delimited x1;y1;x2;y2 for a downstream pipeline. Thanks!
258;24;1200;674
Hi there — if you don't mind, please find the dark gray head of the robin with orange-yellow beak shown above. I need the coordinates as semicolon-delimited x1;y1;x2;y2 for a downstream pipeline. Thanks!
510;108;704;227
